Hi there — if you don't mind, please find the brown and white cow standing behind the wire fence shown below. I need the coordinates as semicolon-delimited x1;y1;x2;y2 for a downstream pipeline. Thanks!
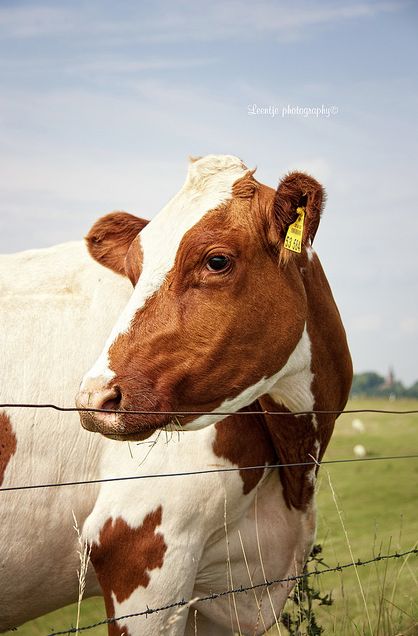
0;155;352;636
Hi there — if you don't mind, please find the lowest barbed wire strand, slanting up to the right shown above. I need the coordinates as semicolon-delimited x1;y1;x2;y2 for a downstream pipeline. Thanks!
48;548;418;636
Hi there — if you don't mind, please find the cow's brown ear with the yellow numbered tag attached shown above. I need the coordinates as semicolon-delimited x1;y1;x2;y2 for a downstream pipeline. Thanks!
273;172;326;262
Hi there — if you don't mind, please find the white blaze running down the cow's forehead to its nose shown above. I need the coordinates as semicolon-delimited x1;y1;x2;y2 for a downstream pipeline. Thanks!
81;155;248;389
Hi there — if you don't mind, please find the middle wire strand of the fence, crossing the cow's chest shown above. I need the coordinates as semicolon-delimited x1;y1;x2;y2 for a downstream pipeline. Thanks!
0;454;418;492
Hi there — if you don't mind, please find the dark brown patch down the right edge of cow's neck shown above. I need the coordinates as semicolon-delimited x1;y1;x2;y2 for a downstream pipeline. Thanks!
260;250;353;509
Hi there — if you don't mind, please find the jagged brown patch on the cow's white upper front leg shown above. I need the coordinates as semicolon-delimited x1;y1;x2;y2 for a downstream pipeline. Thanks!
91;506;167;612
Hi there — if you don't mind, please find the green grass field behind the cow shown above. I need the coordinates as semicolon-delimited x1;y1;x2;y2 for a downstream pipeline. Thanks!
13;400;418;636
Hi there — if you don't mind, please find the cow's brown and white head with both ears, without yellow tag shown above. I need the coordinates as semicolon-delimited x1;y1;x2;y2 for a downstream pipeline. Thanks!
77;156;323;439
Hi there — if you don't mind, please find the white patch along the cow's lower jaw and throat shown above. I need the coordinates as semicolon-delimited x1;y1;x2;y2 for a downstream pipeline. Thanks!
183;326;314;430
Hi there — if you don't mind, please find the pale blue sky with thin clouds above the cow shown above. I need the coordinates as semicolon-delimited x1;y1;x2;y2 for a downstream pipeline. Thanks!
0;0;418;385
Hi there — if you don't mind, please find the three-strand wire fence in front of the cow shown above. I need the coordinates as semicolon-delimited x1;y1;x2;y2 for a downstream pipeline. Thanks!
0;403;418;636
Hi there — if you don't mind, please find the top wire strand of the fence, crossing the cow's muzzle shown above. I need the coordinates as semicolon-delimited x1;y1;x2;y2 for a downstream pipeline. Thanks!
0;402;418;417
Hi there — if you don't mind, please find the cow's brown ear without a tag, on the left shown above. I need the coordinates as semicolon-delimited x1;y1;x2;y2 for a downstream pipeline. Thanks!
86;212;148;276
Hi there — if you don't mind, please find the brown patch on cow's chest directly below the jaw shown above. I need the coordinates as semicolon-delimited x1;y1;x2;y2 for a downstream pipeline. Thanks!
212;402;277;495
